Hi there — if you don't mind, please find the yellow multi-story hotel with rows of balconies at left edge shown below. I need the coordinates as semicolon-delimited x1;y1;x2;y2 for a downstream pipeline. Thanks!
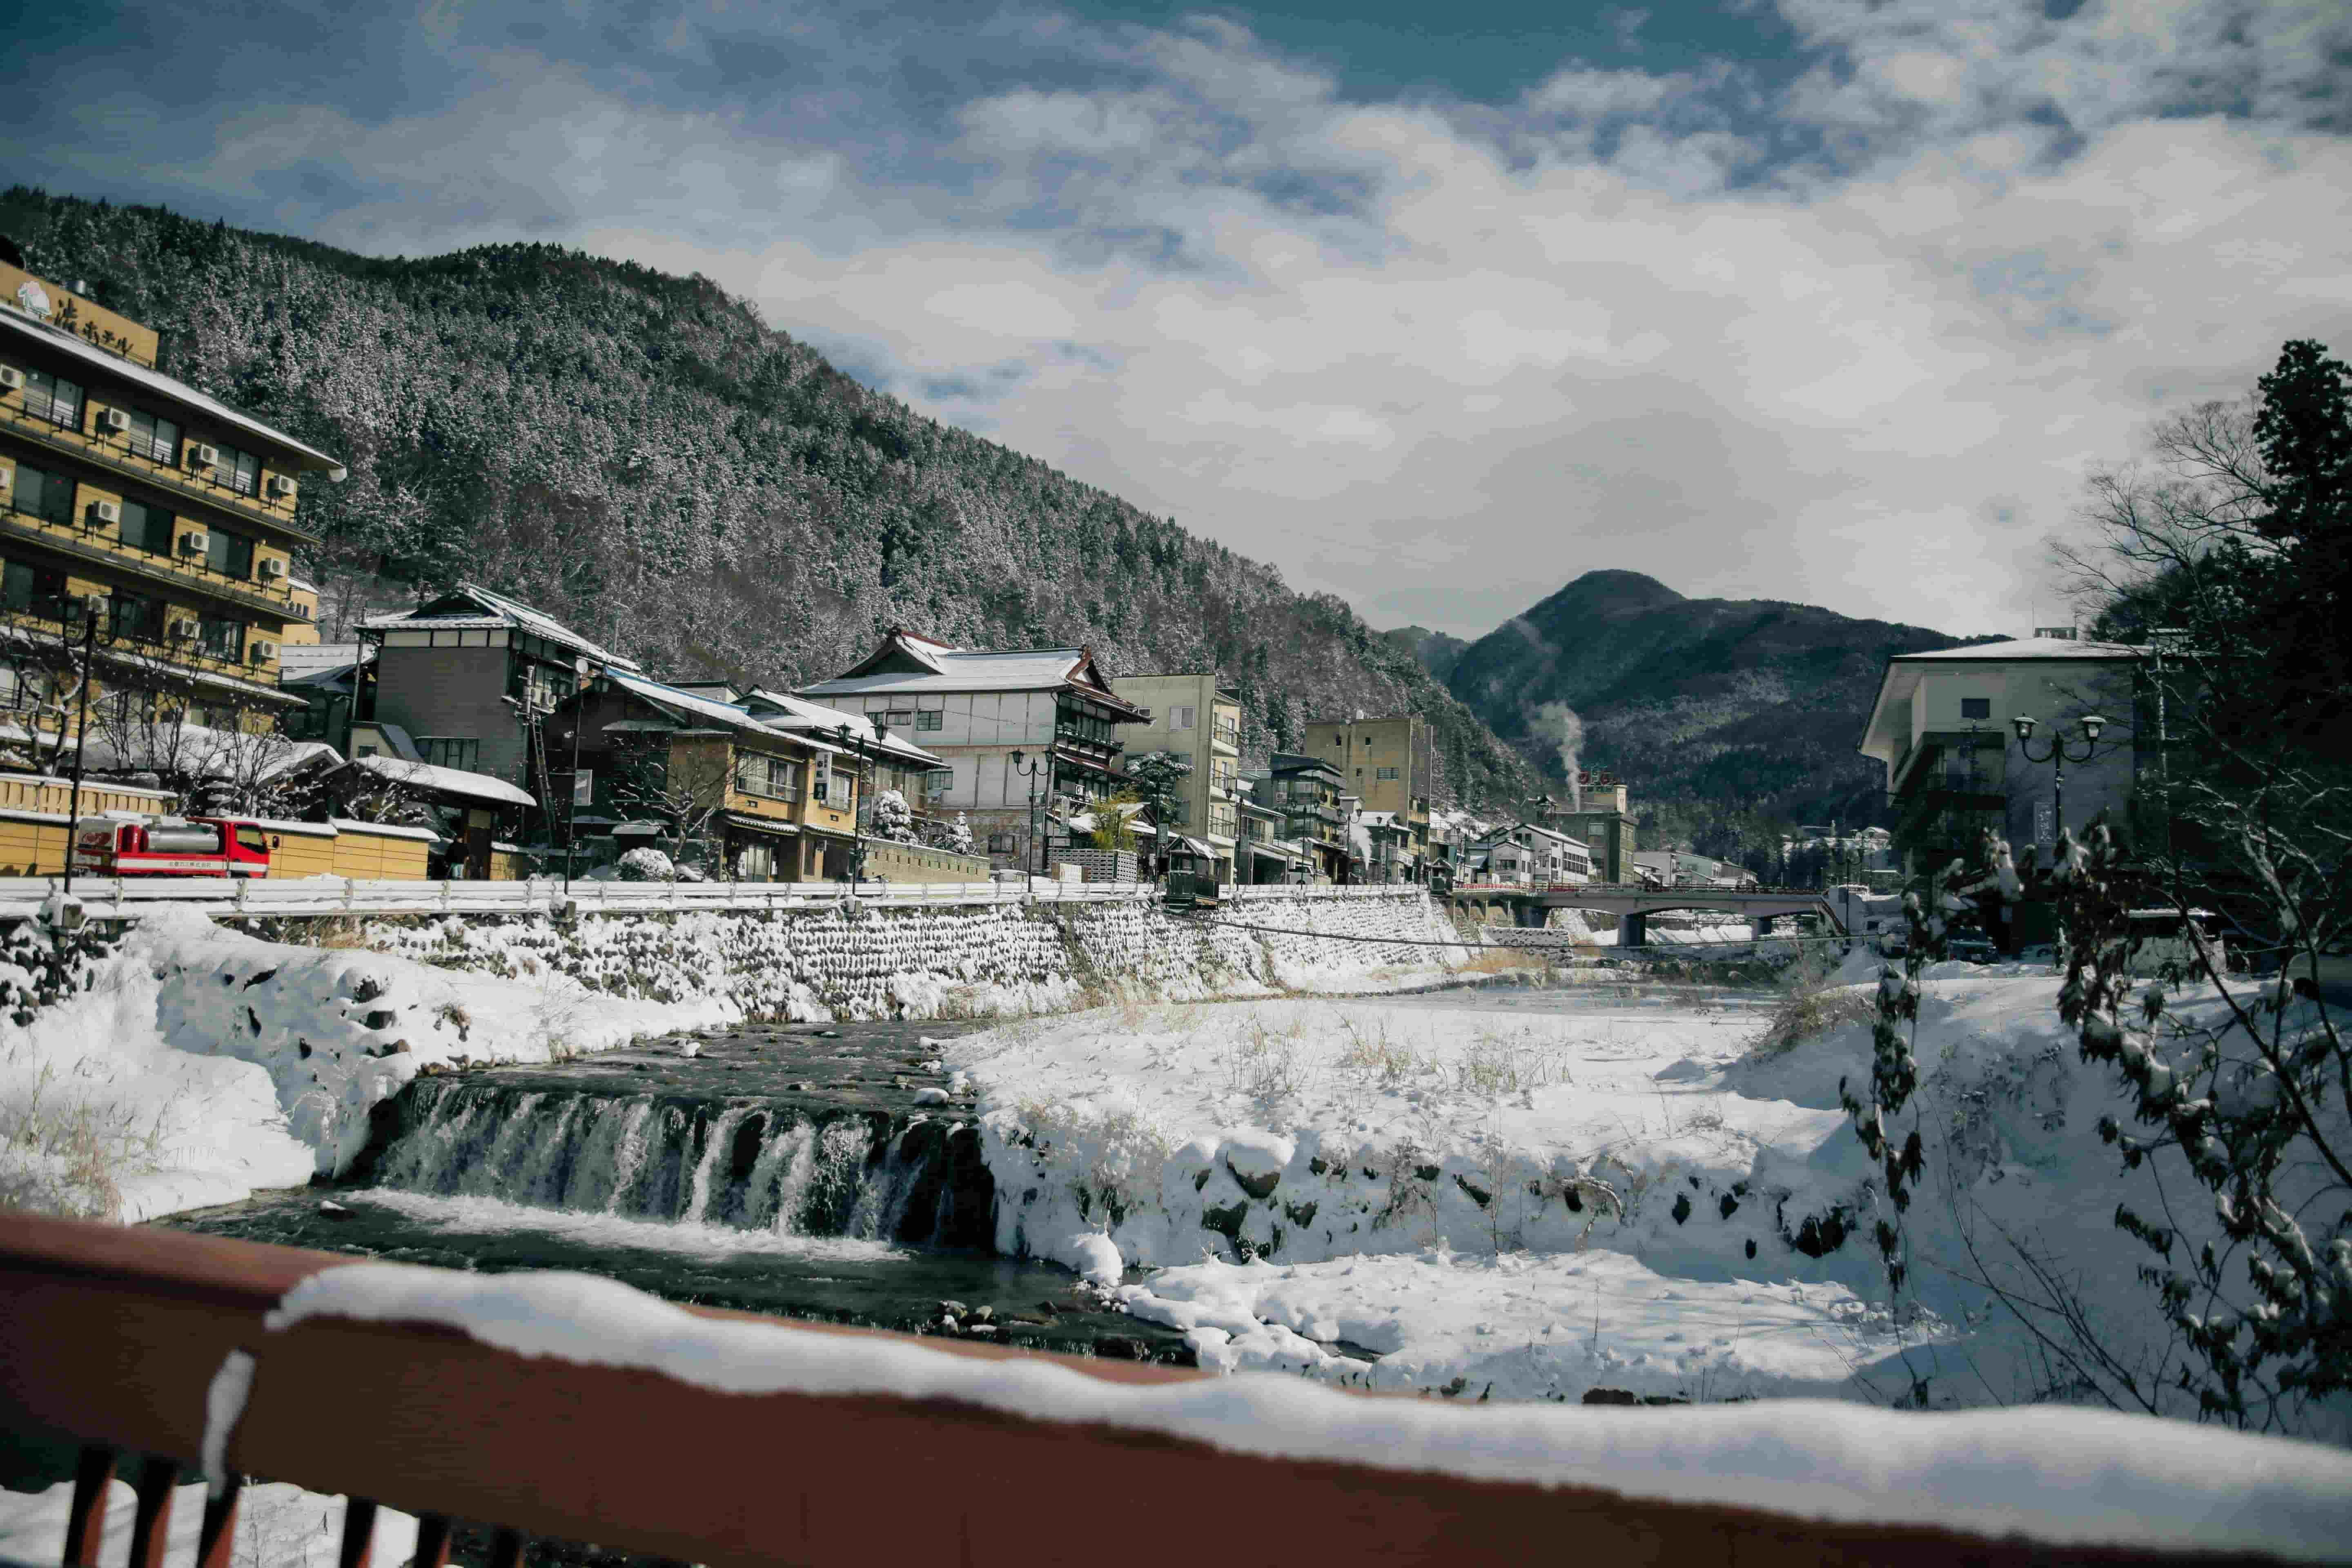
0;263;343;736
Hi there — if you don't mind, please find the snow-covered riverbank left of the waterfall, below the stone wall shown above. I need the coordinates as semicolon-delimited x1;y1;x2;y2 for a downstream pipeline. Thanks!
0;910;731;1220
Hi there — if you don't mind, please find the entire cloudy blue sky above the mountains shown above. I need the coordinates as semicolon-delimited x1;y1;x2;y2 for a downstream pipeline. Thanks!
0;0;2352;635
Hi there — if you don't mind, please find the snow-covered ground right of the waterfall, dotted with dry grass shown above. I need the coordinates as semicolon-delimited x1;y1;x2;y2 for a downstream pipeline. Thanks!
948;954;2352;1437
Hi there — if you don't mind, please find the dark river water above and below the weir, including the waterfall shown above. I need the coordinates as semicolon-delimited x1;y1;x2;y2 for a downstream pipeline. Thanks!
162;1022;1188;1359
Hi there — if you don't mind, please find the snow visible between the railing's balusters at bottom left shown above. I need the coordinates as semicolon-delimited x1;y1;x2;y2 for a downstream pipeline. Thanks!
0;1481;416;1568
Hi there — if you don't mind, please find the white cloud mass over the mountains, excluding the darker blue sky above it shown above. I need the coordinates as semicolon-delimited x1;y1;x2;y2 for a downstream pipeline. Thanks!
137;0;2352;633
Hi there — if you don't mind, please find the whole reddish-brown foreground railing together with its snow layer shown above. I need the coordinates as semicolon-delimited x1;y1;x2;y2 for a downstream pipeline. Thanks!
0;1213;2352;1568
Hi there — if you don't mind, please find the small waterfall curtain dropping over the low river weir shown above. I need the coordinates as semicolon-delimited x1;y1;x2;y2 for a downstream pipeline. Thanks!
360;1077;993;1248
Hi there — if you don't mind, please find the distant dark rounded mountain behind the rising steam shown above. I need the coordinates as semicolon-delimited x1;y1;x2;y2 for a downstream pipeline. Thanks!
1446;571;1985;856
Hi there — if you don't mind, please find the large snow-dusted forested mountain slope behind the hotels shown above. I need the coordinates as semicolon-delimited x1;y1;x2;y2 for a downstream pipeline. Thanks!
0;188;1531;804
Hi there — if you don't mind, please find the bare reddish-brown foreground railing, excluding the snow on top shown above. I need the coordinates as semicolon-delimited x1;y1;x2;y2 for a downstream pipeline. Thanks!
0;1213;2251;1568
